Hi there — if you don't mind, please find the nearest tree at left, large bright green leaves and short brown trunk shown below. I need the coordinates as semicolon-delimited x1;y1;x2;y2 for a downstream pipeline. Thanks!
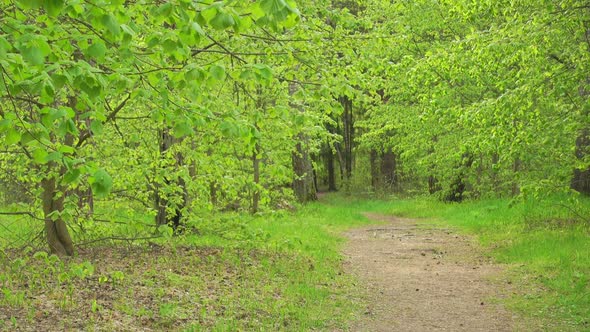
0;0;298;255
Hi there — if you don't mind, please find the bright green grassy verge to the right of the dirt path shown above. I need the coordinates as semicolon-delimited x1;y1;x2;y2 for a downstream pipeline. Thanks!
380;197;590;331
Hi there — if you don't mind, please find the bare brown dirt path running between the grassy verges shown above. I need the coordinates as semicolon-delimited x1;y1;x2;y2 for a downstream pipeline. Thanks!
345;214;515;332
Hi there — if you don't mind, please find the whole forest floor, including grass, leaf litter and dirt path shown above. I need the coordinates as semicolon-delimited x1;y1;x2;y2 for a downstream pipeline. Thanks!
0;195;590;331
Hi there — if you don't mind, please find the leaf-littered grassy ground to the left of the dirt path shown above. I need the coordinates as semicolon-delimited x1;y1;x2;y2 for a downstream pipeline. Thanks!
0;197;384;331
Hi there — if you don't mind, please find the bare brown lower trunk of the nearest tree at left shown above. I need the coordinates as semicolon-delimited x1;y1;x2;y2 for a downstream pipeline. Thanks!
41;178;74;256
